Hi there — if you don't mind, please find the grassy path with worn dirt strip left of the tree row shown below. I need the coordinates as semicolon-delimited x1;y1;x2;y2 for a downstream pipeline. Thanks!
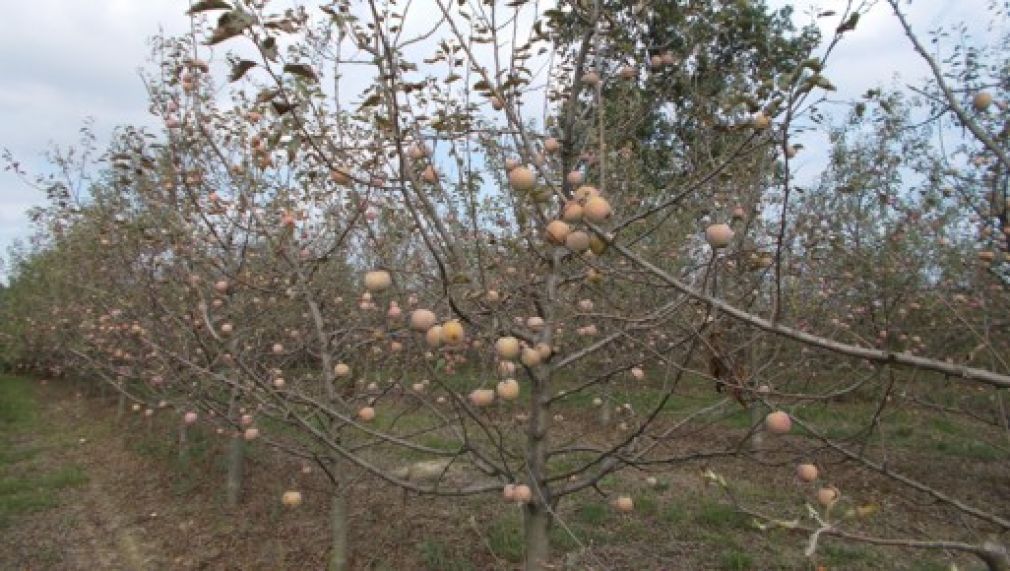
0;377;157;570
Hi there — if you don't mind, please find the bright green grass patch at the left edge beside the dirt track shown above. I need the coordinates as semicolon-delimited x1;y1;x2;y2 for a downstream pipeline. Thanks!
0;377;88;528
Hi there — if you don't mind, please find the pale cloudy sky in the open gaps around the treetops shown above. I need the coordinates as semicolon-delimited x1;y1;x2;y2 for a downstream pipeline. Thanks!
0;0;987;279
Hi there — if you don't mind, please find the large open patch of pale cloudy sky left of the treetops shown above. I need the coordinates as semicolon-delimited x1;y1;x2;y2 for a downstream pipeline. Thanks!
0;0;188;272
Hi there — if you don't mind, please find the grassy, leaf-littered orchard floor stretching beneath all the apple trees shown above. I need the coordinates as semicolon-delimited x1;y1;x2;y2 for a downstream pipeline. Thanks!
0;371;1010;571
